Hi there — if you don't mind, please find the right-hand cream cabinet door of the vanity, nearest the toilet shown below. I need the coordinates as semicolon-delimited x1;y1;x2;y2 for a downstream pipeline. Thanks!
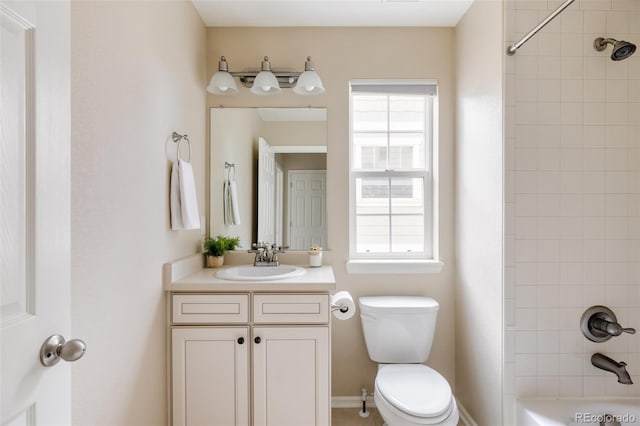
251;327;330;426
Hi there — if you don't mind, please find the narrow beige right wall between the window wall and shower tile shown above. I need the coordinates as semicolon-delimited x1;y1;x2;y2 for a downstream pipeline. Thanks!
455;0;504;425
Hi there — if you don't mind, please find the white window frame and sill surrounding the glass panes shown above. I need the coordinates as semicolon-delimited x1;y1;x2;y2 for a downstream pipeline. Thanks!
347;79;443;273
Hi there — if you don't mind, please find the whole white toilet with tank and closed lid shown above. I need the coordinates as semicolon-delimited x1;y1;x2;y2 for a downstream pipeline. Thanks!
359;296;459;426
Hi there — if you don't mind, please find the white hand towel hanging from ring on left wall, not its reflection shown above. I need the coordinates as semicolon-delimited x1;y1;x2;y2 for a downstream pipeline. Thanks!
170;159;200;230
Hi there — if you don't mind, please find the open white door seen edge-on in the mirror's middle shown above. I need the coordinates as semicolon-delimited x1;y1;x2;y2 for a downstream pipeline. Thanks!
257;138;276;244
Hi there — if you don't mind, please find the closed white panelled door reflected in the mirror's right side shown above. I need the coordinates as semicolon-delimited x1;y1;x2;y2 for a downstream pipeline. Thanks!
289;170;327;250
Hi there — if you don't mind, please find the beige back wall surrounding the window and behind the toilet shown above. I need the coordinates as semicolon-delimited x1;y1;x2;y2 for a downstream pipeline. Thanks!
207;28;455;396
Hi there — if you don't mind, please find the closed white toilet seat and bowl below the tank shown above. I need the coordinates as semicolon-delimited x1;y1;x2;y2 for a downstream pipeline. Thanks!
375;364;458;425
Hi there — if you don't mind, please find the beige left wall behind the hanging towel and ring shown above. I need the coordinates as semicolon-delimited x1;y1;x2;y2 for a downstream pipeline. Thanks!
71;1;207;426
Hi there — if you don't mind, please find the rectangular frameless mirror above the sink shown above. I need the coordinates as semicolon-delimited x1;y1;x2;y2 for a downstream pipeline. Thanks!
209;107;327;250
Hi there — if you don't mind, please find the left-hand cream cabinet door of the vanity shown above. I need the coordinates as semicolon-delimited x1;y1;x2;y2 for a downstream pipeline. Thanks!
172;327;250;426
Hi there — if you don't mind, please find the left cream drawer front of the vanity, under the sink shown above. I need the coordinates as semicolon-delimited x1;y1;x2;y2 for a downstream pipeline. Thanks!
172;294;249;324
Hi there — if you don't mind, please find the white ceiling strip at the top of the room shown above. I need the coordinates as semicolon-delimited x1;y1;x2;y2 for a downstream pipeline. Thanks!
192;0;473;27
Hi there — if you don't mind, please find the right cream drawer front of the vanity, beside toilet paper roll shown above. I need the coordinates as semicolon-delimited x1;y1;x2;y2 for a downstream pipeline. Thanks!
253;294;329;324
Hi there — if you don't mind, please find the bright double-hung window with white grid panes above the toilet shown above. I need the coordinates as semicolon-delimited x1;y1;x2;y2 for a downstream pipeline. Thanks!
350;81;437;272
